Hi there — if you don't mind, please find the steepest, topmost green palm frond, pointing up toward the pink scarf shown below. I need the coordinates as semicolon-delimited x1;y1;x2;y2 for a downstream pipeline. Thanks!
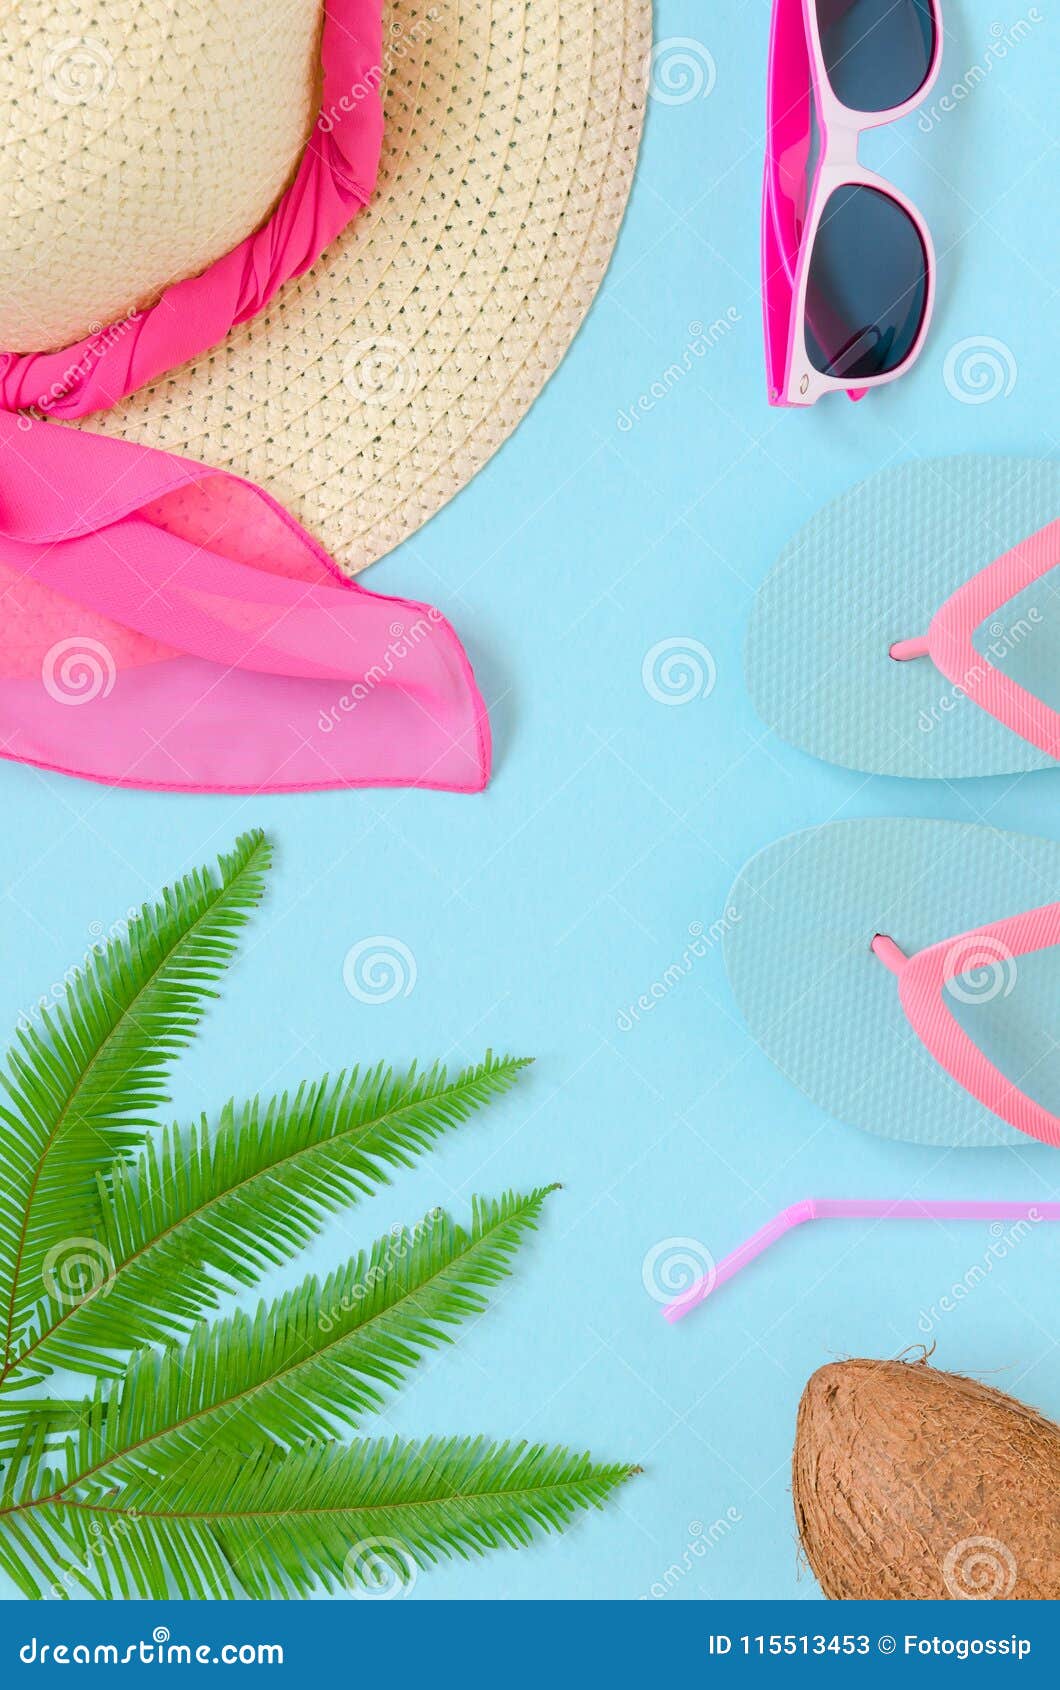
0;833;270;1379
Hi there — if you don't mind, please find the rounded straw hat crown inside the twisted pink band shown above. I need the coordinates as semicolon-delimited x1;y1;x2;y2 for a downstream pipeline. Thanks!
0;0;323;352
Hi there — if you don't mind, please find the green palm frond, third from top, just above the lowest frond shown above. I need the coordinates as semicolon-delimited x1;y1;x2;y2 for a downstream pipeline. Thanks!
39;1186;555;1496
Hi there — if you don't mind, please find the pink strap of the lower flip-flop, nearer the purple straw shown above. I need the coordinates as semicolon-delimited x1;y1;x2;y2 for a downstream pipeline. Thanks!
872;902;1060;1144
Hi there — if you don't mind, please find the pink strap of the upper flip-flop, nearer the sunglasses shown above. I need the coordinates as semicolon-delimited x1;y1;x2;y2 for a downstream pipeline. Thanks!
891;521;1060;759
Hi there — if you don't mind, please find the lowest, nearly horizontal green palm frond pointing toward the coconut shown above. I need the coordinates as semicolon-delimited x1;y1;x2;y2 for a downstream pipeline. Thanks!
16;1438;636;1599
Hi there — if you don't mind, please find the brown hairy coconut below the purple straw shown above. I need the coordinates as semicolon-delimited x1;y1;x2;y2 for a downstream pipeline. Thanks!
791;1355;1060;1600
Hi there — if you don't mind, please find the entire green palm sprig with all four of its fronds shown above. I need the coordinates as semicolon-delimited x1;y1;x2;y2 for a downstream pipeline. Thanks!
0;833;636;1599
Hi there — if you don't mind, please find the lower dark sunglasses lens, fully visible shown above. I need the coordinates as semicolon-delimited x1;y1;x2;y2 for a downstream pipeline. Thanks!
805;183;928;382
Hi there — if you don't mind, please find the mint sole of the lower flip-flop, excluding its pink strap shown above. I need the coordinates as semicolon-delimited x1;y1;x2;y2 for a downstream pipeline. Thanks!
725;820;1060;1151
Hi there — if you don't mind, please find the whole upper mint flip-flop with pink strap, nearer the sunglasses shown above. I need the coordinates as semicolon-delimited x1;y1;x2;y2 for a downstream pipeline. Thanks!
746;456;1060;781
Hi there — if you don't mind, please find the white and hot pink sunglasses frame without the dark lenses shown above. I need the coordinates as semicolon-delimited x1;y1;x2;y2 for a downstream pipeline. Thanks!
762;0;942;406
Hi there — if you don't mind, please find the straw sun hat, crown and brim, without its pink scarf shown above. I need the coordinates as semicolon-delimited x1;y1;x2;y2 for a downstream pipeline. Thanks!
0;0;651;573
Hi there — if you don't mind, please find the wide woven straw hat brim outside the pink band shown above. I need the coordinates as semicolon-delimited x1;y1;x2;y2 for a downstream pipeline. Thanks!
8;0;651;573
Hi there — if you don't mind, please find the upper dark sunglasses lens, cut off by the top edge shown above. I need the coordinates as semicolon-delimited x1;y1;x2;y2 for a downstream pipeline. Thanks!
817;0;935;112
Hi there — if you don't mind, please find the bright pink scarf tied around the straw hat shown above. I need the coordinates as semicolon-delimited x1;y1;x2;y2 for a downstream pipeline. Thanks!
0;0;490;793
